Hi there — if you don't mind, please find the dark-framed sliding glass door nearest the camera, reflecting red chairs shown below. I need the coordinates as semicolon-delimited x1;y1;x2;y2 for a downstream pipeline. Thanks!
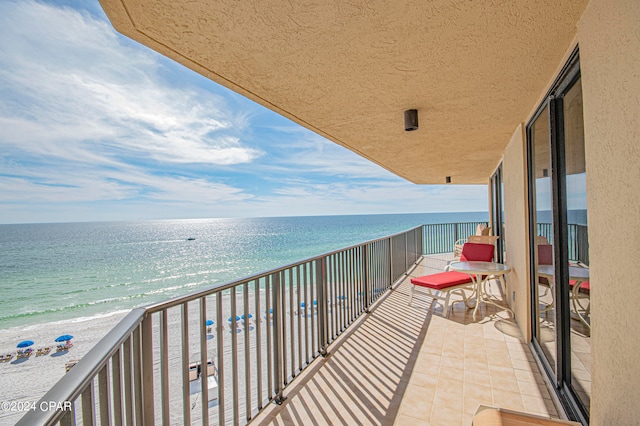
527;51;591;423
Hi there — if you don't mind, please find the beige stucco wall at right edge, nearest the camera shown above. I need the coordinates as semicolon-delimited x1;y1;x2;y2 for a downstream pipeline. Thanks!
578;0;640;425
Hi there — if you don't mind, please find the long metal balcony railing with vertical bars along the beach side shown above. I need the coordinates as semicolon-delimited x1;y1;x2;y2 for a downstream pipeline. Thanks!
18;227;428;425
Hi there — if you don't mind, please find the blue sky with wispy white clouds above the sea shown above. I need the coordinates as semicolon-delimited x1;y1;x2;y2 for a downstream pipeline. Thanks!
0;0;487;224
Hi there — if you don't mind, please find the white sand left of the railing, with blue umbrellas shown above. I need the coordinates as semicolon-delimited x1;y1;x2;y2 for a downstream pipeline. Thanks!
0;311;127;425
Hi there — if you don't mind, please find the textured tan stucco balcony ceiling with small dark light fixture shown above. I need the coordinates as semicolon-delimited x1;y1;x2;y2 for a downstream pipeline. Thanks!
100;0;587;183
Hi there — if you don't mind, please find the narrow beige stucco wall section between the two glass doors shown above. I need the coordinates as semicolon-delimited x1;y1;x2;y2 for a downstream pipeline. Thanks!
502;125;531;341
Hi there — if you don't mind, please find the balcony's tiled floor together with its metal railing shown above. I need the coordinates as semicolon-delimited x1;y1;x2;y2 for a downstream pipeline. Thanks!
18;223;558;425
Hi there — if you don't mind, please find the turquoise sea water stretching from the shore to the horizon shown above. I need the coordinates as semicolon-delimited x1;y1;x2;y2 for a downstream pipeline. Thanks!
0;212;488;329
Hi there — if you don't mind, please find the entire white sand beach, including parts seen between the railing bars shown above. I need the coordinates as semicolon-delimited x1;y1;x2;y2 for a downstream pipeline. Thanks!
0;288;350;425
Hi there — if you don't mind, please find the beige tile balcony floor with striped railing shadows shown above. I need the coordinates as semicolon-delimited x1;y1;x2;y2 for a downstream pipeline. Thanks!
251;257;558;426
